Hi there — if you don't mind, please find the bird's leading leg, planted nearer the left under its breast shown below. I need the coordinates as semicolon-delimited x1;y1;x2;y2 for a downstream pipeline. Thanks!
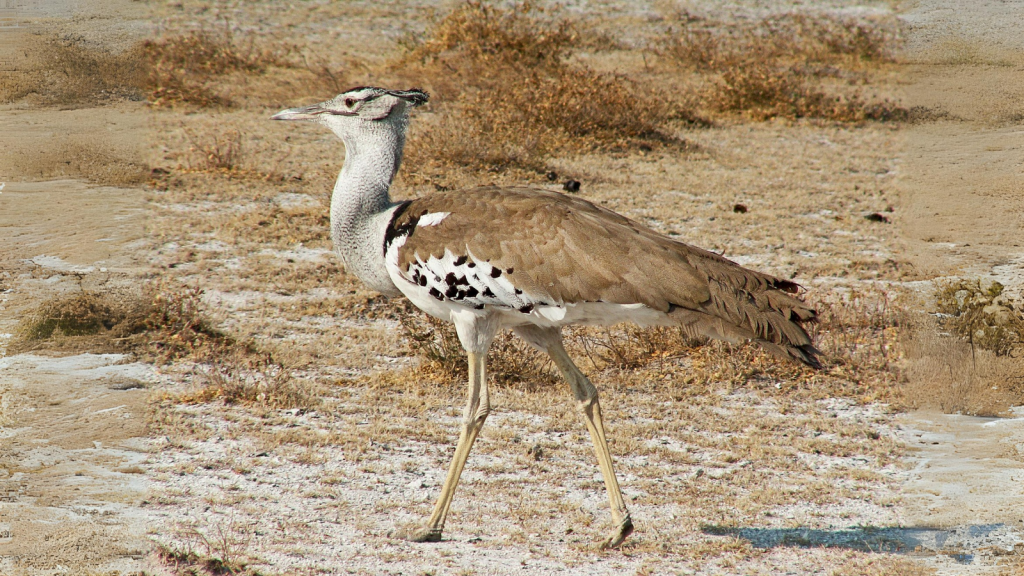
399;352;490;542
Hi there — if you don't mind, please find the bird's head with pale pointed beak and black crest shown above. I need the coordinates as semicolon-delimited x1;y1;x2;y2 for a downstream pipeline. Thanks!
270;86;429;141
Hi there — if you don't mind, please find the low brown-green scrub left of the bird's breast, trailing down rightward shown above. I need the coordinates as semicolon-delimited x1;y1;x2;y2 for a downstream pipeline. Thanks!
8;284;321;409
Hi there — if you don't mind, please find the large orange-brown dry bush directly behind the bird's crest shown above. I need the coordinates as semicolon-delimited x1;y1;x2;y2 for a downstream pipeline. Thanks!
392;2;691;178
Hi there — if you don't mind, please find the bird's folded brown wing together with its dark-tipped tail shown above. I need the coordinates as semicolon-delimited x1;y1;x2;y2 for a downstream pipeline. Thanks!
393;187;816;365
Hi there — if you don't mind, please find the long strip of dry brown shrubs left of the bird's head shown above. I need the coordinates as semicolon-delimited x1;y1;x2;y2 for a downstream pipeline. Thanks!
0;26;347;109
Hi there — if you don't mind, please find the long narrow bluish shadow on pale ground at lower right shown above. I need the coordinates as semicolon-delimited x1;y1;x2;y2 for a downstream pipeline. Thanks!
702;524;1024;564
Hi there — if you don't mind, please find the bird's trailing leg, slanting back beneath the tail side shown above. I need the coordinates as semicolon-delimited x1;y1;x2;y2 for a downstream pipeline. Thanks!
515;327;633;548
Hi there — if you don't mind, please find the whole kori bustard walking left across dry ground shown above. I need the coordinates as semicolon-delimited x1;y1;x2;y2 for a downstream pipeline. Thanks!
273;87;818;546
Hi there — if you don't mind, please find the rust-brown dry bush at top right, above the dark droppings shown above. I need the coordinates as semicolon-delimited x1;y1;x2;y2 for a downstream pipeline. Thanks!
662;14;909;122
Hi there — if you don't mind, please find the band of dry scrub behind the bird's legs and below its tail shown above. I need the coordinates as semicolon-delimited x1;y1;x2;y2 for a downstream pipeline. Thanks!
391;282;908;405
